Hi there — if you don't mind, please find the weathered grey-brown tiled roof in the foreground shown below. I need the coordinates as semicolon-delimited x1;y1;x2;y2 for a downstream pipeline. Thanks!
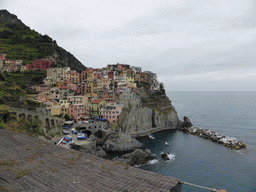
0;129;181;192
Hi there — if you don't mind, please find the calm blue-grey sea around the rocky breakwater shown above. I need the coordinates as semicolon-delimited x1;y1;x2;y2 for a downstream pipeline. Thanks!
138;91;256;192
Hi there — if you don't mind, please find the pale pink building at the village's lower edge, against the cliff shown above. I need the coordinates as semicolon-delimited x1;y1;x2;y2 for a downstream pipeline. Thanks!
103;103;123;123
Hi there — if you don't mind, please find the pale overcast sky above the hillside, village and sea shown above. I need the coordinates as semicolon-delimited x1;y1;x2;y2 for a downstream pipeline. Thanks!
0;0;256;91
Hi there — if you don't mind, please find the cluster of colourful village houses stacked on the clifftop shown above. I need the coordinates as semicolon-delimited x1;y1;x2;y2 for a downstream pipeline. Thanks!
0;54;160;122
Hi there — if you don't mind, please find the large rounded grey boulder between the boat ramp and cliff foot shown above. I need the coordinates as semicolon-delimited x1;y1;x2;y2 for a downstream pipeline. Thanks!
102;133;142;152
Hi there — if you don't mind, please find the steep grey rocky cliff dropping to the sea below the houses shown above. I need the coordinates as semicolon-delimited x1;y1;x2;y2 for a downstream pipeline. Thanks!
114;83;182;133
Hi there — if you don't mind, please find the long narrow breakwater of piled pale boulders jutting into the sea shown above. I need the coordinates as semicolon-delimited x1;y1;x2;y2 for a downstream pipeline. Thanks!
182;126;246;149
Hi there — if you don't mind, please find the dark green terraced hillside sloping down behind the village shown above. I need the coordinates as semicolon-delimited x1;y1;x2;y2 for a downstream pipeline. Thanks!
0;10;86;72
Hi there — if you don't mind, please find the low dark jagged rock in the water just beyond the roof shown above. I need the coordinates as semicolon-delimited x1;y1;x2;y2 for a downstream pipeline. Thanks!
113;149;157;166
